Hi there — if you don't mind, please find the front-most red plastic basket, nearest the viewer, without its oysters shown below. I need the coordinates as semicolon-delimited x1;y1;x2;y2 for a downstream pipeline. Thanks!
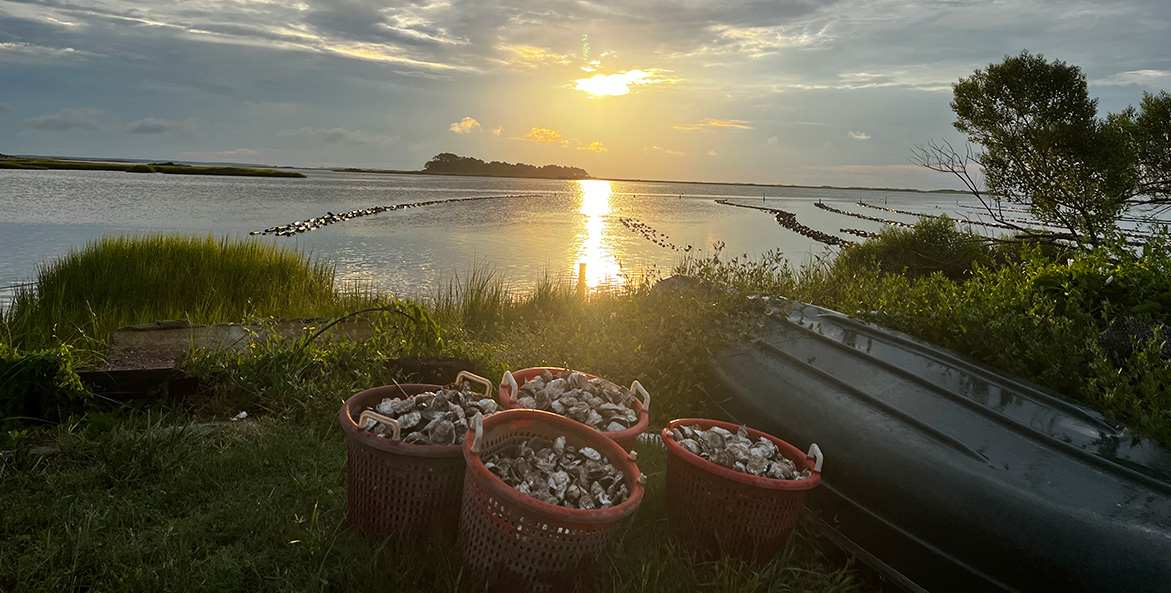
459;409;643;592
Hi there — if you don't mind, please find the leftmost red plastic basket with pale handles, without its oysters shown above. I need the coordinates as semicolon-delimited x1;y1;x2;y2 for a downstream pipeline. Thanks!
338;373;492;539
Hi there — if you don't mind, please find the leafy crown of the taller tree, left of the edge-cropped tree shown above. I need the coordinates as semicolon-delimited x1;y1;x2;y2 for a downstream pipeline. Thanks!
952;52;1137;244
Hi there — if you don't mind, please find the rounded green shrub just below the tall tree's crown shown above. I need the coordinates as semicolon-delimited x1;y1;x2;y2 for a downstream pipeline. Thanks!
834;217;995;280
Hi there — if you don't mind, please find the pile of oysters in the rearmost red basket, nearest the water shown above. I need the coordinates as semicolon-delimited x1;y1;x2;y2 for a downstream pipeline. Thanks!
515;370;638;432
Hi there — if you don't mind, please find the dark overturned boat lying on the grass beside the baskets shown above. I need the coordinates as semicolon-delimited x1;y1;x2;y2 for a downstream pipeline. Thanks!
708;302;1171;593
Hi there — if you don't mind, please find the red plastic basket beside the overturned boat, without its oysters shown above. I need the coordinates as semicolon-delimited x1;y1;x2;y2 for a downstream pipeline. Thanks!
663;418;822;565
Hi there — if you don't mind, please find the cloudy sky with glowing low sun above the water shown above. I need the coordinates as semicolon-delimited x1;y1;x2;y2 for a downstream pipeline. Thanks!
0;0;1171;189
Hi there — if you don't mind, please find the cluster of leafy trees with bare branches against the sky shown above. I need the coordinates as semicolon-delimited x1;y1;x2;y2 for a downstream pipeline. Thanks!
912;52;1171;245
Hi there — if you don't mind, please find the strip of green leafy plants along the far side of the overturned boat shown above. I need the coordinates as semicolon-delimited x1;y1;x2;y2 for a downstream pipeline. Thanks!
682;240;1171;441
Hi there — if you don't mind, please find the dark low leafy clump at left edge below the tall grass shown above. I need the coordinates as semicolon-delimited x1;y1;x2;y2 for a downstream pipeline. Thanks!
0;342;93;425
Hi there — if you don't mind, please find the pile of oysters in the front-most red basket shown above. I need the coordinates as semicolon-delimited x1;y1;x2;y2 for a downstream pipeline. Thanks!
482;436;630;509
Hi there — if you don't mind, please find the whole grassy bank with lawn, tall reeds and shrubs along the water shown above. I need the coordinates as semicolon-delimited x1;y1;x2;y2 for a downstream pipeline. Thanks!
0;226;1171;592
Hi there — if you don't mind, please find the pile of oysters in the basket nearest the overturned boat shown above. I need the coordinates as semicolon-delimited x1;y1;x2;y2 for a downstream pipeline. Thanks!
671;425;813;479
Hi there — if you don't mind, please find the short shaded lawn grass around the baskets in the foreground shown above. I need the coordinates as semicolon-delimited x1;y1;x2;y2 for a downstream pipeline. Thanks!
0;414;861;592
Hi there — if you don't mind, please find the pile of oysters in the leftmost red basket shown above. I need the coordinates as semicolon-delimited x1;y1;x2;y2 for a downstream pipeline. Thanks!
363;386;498;445
